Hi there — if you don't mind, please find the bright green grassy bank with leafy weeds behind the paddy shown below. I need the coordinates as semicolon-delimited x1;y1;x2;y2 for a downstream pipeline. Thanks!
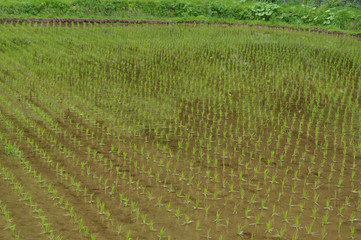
0;0;361;32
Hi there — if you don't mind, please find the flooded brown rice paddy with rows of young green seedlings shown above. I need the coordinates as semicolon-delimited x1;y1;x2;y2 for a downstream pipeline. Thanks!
0;24;361;240
